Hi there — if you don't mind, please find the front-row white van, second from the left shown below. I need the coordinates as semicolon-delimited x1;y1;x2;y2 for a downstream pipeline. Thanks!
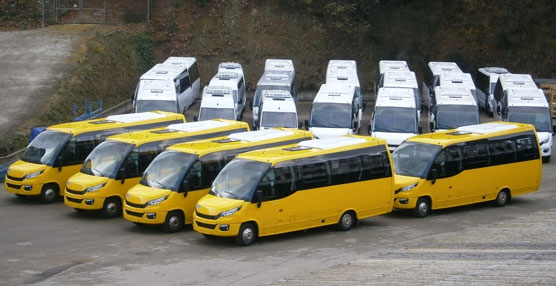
198;86;242;120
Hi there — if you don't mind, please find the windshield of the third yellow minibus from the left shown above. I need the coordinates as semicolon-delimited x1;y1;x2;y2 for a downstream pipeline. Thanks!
140;150;199;191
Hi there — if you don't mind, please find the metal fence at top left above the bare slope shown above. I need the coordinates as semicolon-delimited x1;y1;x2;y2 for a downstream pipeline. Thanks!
41;0;153;26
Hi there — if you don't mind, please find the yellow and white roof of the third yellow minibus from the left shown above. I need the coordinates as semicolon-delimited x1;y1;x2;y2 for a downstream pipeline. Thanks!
168;128;313;157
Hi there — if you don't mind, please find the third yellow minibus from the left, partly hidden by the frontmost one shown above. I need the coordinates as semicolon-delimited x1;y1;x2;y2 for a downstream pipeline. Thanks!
124;128;313;232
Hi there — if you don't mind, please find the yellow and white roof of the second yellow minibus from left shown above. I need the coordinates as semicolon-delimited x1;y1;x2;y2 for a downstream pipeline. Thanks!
107;119;249;146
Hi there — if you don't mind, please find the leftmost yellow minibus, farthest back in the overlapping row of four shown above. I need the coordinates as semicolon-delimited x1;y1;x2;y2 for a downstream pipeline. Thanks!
4;111;185;203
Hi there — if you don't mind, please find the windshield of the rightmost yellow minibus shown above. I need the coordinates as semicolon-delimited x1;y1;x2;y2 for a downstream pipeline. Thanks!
392;141;441;179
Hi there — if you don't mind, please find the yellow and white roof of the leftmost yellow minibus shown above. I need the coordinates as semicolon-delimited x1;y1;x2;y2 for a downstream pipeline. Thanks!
48;111;185;135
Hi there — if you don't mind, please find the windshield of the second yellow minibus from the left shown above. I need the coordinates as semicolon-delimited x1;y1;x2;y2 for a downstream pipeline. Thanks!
81;140;135;179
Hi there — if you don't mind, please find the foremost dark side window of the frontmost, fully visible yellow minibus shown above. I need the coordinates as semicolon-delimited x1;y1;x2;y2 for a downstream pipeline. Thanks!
257;167;293;201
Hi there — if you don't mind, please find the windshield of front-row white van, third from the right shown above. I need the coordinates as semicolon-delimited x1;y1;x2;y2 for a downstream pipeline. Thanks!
374;107;417;133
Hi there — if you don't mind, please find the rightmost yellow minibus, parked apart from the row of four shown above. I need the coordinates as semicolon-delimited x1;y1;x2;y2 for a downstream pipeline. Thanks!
392;122;542;217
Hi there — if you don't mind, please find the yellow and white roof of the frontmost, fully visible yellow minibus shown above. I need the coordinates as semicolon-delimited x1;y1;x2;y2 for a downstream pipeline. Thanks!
238;135;388;165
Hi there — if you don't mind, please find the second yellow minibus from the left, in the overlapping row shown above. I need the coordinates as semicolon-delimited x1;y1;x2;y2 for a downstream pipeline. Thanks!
64;119;249;218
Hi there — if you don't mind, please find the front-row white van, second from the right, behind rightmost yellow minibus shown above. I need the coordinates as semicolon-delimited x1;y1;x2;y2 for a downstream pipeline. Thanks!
429;86;479;132
